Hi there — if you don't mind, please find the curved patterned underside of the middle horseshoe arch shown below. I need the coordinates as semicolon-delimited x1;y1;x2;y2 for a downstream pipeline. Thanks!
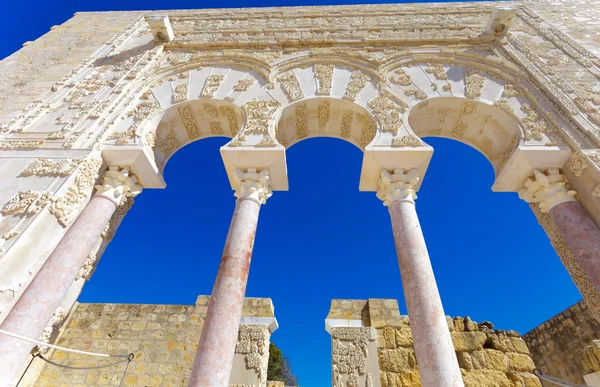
276;98;377;150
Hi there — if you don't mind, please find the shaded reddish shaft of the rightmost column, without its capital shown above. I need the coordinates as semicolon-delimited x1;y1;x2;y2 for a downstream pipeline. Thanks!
549;201;600;292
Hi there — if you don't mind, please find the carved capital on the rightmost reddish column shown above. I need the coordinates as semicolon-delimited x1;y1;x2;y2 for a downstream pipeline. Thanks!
519;168;577;213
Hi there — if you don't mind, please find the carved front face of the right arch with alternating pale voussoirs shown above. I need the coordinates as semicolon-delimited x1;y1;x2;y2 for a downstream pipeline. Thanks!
381;49;590;150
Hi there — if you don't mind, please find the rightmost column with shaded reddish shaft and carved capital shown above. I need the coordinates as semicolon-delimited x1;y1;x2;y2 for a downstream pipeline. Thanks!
519;168;600;292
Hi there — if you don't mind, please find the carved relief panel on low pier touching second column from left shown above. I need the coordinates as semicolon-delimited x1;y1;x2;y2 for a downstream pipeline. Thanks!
235;324;269;386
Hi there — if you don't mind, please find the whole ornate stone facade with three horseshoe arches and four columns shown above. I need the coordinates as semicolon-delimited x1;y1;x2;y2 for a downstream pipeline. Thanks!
0;2;600;386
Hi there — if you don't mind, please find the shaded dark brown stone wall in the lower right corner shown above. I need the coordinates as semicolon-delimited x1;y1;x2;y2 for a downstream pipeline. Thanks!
523;301;600;386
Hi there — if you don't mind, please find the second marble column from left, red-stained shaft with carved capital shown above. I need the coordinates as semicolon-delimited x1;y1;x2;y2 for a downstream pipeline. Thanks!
188;168;271;387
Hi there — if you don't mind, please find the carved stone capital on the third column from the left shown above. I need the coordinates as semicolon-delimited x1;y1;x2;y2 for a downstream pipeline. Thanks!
377;168;419;207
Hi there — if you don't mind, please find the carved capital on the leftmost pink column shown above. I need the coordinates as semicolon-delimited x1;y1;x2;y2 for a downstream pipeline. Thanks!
95;165;142;206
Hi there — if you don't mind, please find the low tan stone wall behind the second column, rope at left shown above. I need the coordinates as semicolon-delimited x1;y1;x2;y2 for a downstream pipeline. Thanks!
20;296;276;387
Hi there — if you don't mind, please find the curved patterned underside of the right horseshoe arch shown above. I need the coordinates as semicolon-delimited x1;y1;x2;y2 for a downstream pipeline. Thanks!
408;97;523;175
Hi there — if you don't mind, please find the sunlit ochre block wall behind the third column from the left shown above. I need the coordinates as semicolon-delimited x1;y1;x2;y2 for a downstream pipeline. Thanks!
327;299;541;387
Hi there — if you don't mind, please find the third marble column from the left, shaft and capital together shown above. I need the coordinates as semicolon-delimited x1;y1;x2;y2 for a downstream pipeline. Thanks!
377;169;464;387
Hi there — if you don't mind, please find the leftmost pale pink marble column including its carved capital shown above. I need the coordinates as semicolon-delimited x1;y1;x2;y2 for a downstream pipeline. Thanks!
0;167;141;387
